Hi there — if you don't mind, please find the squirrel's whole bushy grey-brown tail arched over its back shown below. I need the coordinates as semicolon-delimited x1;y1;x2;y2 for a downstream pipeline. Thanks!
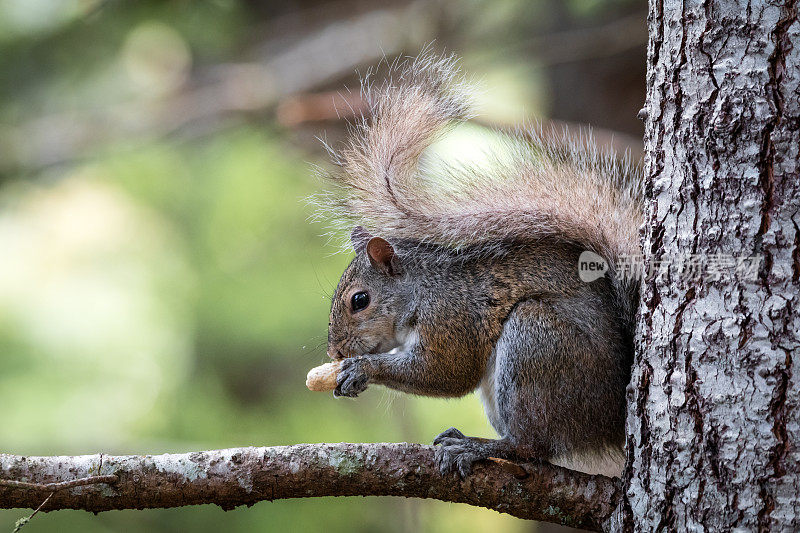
324;54;642;324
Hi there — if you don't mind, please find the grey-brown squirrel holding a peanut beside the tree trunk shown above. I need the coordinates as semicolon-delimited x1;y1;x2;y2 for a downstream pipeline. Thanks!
317;53;643;477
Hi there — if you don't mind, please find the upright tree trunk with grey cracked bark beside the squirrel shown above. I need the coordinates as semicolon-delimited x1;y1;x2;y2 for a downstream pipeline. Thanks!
617;0;800;531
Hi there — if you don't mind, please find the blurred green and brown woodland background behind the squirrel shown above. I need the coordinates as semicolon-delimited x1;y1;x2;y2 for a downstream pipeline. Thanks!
0;0;646;533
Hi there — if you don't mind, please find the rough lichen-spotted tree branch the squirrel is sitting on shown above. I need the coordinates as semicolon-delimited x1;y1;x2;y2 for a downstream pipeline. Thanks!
0;443;619;531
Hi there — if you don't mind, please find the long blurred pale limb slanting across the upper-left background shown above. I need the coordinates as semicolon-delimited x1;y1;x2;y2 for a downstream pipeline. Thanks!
0;2;433;171
